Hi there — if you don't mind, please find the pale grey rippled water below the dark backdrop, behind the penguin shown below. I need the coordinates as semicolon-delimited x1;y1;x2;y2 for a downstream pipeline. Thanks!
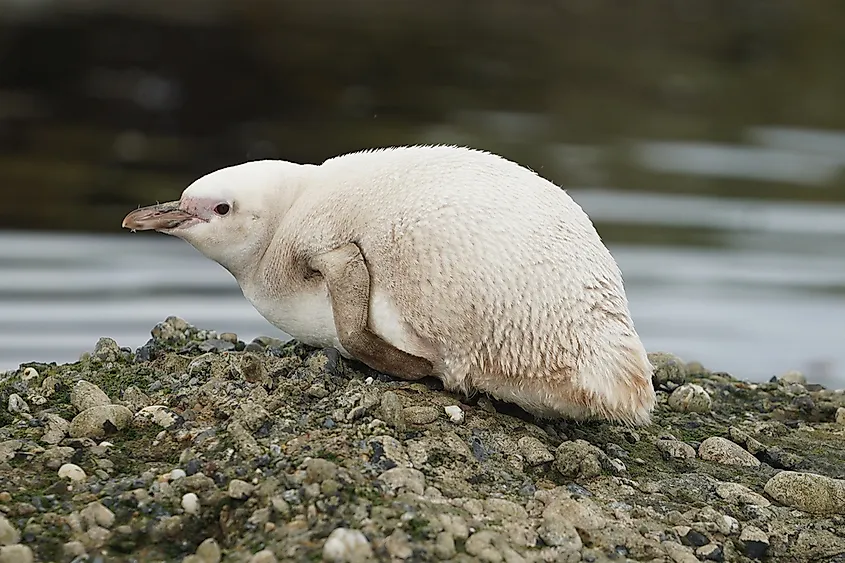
0;180;845;387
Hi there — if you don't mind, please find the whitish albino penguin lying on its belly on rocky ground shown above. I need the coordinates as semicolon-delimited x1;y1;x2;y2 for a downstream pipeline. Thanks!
123;146;655;425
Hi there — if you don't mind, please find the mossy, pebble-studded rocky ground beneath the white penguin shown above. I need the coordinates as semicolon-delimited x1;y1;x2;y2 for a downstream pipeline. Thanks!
0;318;845;563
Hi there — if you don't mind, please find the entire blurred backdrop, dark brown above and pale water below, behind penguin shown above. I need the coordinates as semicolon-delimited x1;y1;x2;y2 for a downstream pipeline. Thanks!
0;0;845;387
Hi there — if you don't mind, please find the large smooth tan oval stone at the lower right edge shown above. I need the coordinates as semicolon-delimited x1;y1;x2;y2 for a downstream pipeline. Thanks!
763;471;845;514
